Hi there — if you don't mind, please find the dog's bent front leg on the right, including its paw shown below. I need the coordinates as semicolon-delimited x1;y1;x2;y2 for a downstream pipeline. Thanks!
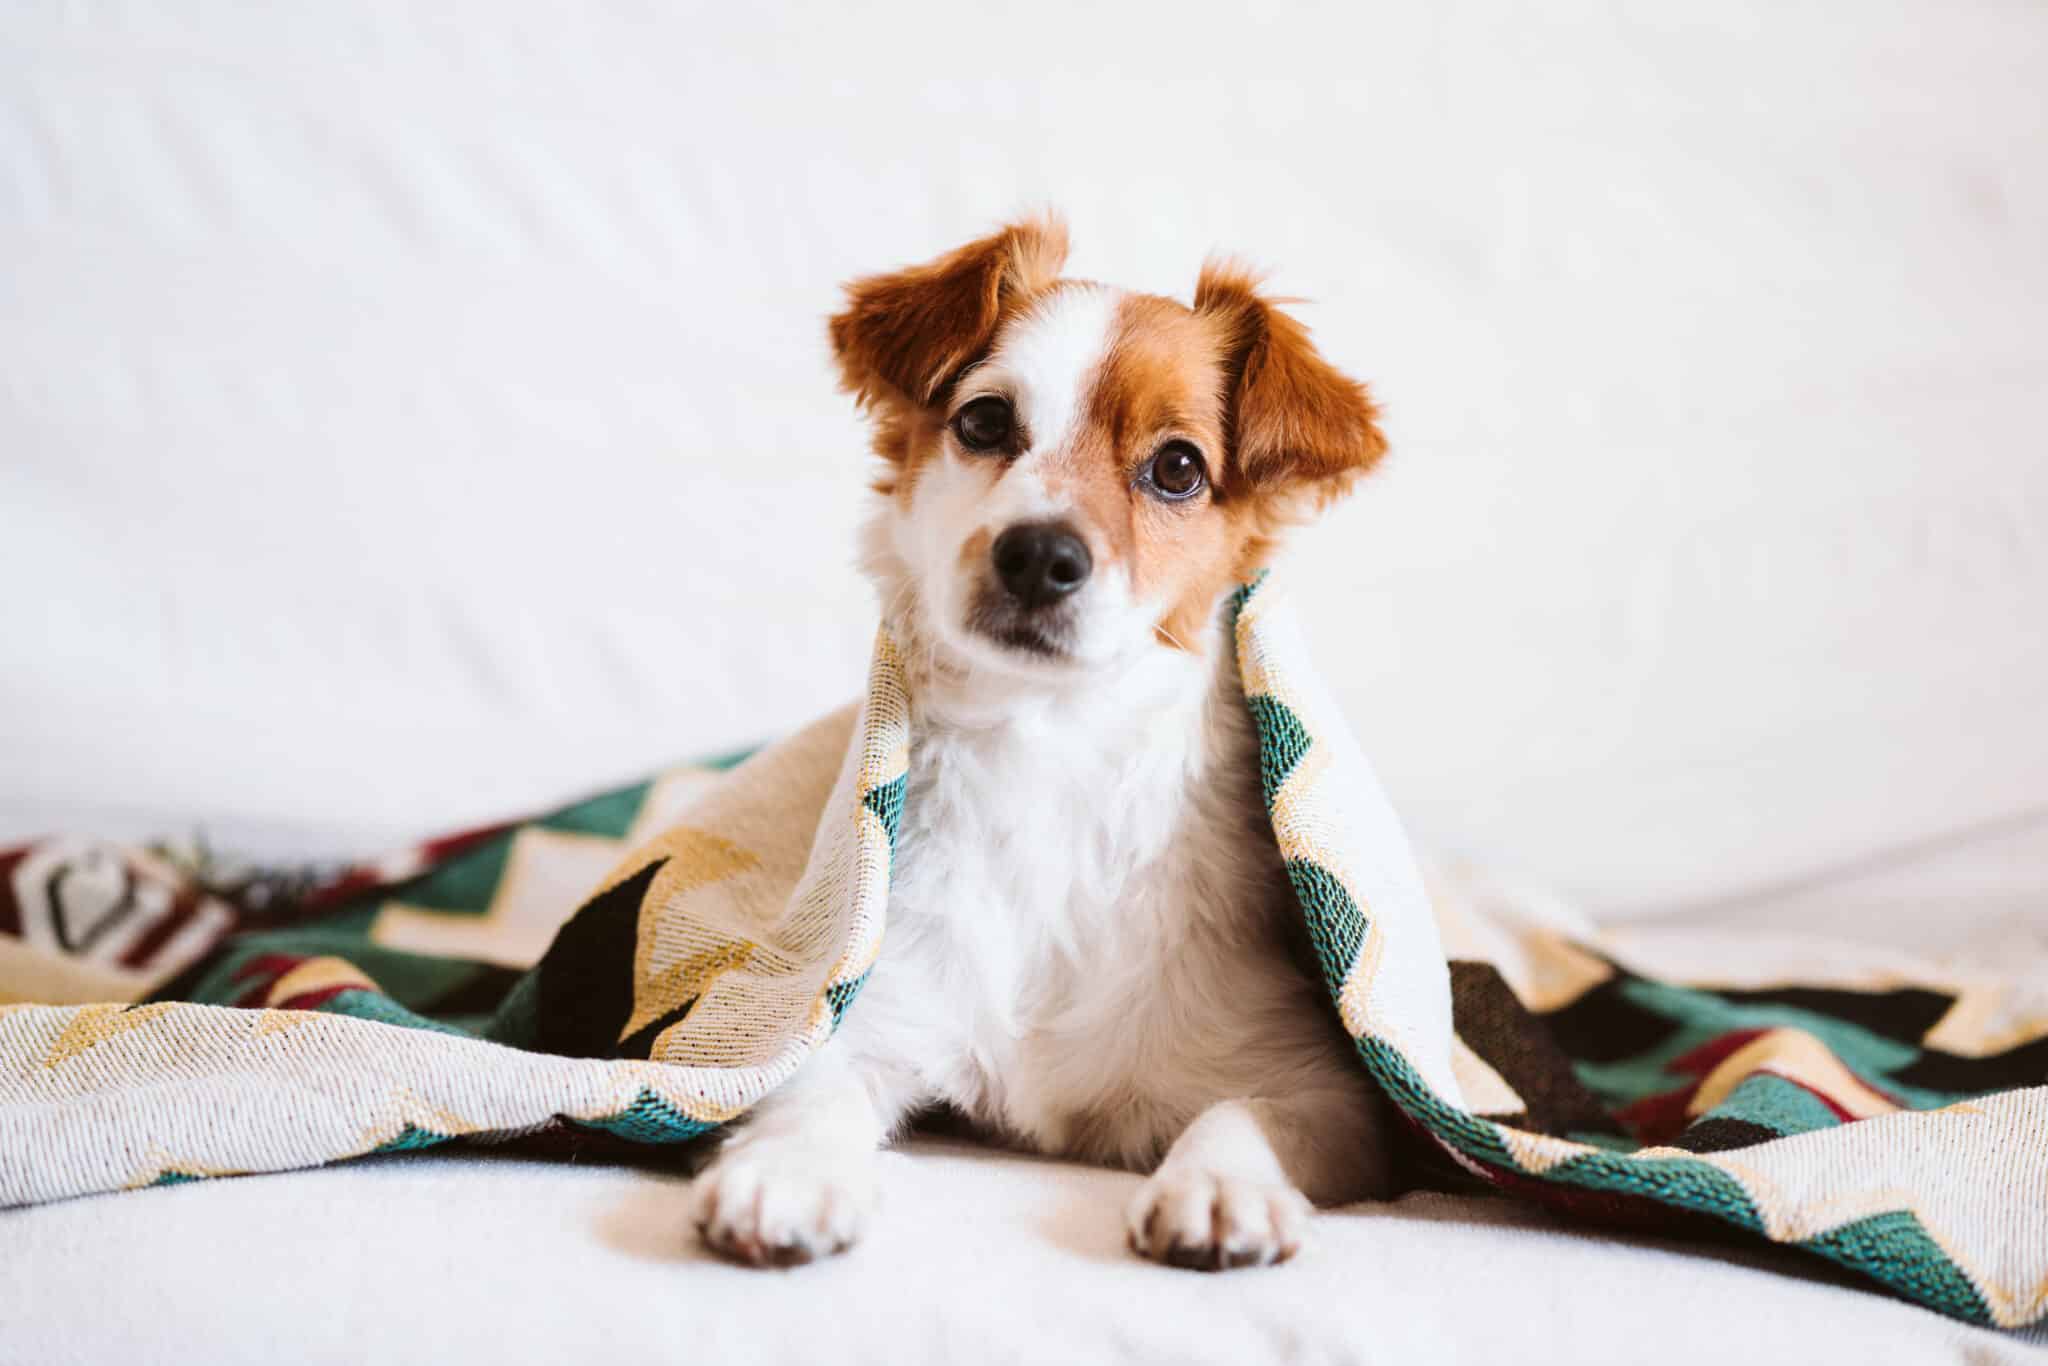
1128;1092;1389;1272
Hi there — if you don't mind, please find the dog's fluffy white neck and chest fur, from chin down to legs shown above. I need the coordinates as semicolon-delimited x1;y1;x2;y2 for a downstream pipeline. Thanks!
862;532;1315;1165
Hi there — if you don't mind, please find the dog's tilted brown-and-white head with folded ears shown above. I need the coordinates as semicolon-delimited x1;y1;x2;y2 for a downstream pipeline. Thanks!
831;221;1384;676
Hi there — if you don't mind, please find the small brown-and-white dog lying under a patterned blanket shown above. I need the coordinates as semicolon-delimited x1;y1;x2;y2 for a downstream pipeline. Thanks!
692;221;1391;1268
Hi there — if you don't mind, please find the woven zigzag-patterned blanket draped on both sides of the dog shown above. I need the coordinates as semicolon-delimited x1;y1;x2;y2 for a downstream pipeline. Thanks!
0;584;2048;1327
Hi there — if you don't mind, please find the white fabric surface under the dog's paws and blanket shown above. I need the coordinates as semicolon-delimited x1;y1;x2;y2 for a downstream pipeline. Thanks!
0;1141;2048;1366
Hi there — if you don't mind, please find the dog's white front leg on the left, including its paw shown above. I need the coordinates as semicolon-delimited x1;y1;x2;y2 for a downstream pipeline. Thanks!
690;1042;907;1266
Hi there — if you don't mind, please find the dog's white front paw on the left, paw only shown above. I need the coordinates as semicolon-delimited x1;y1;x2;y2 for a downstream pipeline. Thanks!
690;1141;874;1266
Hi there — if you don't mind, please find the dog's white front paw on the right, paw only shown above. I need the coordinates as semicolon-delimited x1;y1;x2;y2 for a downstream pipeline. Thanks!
1128;1167;1313;1272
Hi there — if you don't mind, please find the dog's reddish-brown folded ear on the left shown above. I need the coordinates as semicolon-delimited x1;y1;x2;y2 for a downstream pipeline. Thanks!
831;215;1067;405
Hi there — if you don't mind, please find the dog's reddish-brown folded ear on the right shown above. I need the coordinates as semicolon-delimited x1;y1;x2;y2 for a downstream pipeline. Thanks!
1194;260;1386;504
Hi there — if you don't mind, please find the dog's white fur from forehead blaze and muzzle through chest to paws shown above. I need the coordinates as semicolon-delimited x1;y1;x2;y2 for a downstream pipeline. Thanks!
696;291;1384;1266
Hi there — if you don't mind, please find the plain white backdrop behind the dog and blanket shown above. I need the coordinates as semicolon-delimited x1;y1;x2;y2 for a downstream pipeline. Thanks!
0;0;2048;926
